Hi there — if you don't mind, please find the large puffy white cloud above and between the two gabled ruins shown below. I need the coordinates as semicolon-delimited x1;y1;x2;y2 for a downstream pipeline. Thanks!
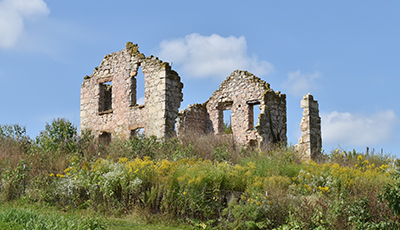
158;33;273;78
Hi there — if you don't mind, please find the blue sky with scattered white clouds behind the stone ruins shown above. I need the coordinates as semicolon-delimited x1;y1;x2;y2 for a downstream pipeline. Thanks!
0;0;400;155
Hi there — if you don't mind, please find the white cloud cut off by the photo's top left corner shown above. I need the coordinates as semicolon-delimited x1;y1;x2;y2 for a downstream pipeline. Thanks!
0;0;50;48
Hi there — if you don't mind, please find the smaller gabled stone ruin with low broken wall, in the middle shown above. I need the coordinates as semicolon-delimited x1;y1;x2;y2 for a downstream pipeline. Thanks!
177;70;287;145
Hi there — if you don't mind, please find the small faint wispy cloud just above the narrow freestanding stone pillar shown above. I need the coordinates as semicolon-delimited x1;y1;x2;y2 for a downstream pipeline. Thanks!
282;70;322;96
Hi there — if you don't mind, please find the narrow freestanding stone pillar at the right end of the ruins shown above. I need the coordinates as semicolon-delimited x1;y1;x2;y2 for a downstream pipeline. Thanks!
296;94;322;160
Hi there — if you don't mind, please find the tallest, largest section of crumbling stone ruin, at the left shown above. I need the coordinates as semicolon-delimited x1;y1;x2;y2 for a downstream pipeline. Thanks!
80;42;183;139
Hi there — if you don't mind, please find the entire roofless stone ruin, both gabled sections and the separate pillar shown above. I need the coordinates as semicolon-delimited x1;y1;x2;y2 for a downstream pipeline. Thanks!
80;42;322;159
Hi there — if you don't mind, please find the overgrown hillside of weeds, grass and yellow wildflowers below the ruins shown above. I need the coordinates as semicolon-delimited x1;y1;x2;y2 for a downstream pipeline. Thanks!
0;119;400;229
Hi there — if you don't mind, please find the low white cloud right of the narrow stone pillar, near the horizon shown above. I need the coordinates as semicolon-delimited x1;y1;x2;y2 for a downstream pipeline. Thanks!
321;110;398;146
